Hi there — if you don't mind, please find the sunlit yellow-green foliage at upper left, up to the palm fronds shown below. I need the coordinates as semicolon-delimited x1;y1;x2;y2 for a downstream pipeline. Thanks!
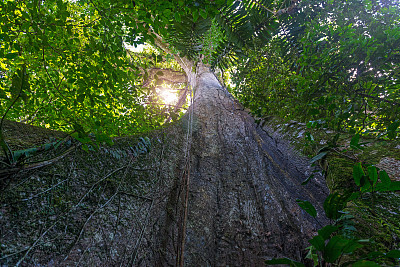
0;0;221;157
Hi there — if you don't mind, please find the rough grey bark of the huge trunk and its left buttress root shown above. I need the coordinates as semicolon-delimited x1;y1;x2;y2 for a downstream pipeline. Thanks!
0;67;328;266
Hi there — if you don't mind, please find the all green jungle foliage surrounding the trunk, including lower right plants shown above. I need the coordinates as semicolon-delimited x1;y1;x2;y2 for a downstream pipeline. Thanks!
0;0;400;266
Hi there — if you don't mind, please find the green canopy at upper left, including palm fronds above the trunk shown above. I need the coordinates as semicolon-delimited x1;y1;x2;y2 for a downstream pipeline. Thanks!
0;0;288;135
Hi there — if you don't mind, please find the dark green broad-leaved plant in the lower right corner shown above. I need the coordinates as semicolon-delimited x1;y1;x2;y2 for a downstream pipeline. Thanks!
272;164;400;266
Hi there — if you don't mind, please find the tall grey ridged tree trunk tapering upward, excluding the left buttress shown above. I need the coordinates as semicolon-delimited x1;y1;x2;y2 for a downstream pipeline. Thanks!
160;65;327;266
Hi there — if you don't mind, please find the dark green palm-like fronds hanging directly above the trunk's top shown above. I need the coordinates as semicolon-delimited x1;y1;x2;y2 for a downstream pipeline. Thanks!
161;0;293;68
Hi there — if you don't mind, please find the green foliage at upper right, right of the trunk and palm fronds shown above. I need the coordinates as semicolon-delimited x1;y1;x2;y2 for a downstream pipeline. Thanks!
233;1;400;139
